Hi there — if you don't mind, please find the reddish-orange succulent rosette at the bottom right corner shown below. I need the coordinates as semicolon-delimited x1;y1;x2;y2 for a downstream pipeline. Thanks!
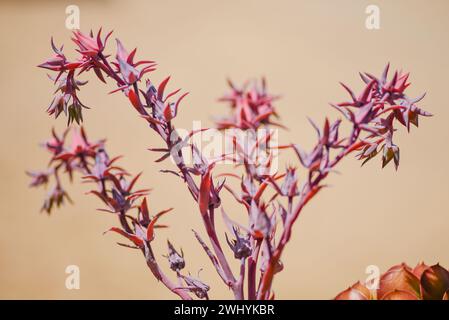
335;262;449;300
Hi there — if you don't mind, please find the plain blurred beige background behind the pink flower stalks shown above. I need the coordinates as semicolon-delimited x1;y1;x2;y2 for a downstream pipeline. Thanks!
0;0;449;299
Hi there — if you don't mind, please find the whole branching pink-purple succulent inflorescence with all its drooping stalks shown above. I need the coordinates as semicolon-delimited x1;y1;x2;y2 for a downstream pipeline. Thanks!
29;30;430;300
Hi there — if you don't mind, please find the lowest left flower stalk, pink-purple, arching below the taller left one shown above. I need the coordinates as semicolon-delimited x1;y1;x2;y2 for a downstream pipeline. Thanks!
29;128;190;299
